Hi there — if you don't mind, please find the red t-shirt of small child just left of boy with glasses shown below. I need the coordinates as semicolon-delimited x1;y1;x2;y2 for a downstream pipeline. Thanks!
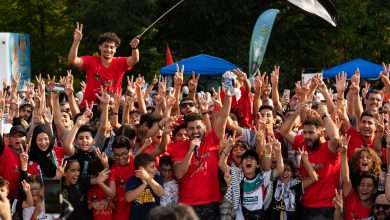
87;185;114;220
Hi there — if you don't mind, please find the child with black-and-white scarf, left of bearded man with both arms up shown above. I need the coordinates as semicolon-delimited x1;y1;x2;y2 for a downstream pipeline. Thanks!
271;149;318;220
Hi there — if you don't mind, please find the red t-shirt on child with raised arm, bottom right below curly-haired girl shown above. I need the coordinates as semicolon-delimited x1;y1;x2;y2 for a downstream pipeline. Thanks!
344;189;371;220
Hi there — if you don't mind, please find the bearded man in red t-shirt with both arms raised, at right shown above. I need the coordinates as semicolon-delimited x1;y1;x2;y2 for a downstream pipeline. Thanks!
280;105;340;220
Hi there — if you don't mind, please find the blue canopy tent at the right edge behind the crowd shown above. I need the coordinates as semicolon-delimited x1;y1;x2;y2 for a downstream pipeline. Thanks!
323;58;383;79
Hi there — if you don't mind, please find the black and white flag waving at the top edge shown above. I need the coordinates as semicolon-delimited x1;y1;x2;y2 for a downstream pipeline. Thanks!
288;0;338;27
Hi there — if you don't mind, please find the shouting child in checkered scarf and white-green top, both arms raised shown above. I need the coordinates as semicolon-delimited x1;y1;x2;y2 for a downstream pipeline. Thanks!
223;137;284;220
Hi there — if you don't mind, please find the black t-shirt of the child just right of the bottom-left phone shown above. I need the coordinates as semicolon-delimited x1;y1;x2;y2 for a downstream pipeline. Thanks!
62;177;93;220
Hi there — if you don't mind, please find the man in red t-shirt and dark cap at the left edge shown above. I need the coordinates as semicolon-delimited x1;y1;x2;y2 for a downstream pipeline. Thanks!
0;125;27;199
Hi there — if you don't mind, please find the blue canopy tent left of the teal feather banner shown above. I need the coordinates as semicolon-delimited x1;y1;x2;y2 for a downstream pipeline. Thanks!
160;54;239;91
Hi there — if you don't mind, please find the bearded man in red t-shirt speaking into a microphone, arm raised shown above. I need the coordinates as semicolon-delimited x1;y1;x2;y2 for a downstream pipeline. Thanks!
171;92;232;220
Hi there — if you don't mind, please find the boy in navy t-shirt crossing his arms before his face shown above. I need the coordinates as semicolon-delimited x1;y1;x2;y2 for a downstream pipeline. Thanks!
126;154;164;220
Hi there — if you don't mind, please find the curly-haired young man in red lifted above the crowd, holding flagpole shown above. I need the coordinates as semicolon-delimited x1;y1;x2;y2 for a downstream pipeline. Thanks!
68;22;139;108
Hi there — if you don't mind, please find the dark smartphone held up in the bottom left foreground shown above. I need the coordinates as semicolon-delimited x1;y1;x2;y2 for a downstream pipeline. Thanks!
43;178;62;213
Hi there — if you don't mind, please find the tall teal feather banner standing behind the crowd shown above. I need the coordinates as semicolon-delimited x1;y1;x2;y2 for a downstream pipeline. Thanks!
248;9;279;76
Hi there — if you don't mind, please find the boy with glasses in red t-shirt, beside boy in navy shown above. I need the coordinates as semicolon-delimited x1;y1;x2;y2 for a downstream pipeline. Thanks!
99;135;134;220
